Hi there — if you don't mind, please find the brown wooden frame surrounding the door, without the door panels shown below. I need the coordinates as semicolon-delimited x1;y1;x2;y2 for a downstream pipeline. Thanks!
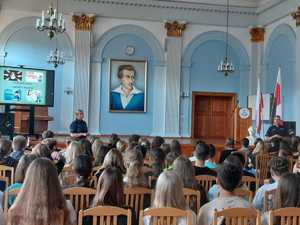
191;91;237;138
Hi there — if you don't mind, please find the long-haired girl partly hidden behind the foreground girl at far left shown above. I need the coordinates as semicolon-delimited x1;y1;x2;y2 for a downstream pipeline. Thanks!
6;154;37;206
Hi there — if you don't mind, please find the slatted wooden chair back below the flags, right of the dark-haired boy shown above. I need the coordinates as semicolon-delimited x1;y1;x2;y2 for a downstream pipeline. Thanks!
256;154;272;184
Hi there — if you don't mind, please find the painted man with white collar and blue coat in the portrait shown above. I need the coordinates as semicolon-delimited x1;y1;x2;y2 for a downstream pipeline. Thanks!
110;65;145;111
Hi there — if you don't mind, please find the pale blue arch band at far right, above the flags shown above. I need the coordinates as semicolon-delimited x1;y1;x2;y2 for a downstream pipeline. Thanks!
265;23;296;63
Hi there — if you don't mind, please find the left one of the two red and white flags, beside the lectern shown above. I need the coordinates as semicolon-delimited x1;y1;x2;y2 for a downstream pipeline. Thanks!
255;78;264;134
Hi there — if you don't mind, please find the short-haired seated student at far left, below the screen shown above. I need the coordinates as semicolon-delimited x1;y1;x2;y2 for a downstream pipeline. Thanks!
4;135;27;167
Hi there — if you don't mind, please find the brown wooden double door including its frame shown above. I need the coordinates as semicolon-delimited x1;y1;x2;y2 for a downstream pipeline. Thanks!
192;92;236;140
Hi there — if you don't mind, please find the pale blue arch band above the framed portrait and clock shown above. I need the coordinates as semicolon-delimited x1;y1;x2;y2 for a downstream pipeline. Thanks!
92;24;164;62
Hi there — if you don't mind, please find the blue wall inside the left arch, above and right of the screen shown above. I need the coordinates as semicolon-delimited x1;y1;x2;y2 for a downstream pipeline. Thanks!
5;27;67;131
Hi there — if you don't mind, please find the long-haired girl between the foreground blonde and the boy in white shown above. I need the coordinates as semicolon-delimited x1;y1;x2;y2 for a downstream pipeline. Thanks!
172;155;207;207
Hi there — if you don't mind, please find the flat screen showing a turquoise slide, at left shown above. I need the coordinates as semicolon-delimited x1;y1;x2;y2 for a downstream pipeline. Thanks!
0;66;55;106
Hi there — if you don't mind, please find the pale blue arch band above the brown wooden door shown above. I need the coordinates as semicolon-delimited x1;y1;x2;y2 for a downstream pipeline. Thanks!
183;31;250;67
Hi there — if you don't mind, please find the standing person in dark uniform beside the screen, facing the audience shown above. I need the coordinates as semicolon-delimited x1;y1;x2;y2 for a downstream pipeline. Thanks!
70;109;88;138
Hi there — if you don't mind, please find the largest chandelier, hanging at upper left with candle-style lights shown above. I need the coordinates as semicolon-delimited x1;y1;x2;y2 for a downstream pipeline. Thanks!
36;1;66;39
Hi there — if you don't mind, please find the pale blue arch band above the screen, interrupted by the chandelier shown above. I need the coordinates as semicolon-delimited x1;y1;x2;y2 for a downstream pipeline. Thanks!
0;17;74;59
